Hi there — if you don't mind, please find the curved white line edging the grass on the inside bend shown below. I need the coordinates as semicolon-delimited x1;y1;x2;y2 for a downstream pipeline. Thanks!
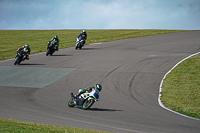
158;52;200;121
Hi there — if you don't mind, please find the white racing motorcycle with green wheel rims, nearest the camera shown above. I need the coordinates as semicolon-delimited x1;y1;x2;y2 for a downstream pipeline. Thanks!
68;89;99;110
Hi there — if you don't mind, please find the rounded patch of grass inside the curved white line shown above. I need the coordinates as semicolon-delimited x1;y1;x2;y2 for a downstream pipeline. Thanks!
161;55;200;118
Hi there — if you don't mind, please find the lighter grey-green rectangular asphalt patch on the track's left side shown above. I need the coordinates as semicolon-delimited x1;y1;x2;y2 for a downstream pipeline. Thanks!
0;66;76;88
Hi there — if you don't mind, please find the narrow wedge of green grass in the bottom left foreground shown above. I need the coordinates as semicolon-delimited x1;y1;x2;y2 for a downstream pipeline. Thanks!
0;118;107;133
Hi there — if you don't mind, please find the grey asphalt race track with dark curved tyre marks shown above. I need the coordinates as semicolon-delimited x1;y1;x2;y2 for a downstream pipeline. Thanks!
0;31;200;133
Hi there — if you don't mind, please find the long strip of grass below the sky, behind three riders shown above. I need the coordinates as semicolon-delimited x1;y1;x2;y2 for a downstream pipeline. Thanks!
0;30;186;61
